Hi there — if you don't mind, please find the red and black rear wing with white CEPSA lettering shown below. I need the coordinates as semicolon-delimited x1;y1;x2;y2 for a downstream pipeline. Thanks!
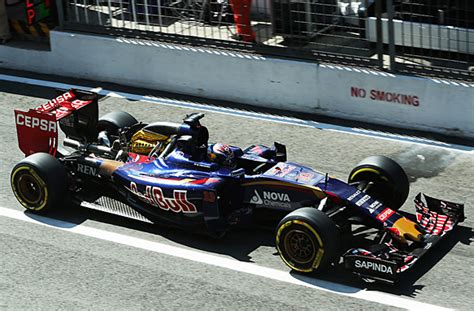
15;89;98;156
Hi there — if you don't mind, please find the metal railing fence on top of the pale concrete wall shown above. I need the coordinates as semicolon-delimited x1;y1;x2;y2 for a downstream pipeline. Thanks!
57;0;474;81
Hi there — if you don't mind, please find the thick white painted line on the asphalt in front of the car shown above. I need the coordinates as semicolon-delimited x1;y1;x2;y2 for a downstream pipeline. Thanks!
0;207;451;311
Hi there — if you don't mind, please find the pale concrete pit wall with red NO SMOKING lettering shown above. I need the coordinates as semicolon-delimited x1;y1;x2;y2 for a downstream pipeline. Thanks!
0;31;474;138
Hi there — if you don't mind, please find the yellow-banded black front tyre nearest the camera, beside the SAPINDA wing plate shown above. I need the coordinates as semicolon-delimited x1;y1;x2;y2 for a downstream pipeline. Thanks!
276;207;340;273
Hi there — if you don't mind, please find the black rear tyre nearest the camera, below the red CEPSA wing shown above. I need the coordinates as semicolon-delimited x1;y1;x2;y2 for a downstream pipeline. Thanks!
10;153;68;213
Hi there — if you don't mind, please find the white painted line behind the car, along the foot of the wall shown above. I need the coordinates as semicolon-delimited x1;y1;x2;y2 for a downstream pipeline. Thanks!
0;74;474;154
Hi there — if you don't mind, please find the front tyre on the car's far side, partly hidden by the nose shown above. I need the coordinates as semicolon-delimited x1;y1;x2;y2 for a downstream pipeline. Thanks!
348;155;410;210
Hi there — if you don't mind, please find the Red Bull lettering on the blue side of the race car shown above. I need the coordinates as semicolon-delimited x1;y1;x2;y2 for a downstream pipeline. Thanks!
127;181;197;214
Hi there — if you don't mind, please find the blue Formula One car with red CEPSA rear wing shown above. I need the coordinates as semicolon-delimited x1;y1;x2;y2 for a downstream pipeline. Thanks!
11;90;464;283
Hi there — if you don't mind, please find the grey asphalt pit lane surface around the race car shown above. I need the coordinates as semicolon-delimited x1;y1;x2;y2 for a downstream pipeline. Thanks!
0;82;474;310
